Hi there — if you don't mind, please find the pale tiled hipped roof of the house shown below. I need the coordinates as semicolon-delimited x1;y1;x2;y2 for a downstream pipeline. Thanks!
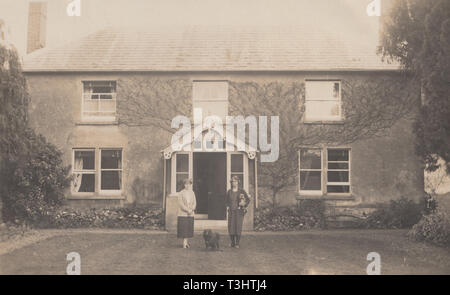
24;26;398;72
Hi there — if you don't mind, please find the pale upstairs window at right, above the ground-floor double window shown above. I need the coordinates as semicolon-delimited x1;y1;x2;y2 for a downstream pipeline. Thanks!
305;81;342;122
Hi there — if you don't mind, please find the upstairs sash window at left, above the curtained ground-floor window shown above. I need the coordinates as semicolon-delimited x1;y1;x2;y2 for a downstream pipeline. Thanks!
82;81;116;121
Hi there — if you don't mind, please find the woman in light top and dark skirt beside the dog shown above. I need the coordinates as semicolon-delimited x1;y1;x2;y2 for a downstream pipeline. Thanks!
177;178;197;248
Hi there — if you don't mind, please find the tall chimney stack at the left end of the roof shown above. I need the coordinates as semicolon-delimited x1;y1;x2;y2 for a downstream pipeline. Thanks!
27;2;47;53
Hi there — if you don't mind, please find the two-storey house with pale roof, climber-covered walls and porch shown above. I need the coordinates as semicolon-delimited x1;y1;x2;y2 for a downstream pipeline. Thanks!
24;27;423;230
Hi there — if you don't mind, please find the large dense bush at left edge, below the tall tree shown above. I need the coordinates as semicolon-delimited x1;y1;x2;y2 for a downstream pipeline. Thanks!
0;129;70;226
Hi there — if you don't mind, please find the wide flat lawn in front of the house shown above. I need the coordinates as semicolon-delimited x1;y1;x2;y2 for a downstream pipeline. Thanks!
0;230;450;274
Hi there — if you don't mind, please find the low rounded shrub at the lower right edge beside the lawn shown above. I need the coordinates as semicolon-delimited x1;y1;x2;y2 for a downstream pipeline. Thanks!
408;212;450;247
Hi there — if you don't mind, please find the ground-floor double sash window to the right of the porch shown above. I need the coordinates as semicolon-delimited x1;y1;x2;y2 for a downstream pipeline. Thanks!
298;148;350;195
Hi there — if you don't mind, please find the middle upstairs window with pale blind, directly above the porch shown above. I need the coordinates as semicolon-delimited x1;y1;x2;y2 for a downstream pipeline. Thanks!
192;81;228;123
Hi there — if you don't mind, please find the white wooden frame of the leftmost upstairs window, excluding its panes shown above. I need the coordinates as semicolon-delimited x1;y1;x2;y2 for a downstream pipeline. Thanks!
81;80;117;122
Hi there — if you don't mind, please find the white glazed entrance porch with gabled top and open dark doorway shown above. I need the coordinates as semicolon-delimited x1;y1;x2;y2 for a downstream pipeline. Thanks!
163;130;257;231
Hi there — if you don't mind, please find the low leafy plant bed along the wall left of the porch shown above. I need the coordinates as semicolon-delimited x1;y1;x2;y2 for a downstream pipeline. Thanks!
41;206;164;229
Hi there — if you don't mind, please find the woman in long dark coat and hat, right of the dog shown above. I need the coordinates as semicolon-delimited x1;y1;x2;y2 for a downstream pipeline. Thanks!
227;176;250;248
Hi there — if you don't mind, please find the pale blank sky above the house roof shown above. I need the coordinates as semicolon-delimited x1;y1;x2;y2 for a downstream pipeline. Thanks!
0;0;378;54
